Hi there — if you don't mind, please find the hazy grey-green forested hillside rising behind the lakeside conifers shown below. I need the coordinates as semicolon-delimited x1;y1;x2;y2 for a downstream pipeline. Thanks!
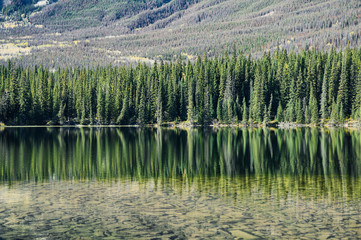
0;0;361;69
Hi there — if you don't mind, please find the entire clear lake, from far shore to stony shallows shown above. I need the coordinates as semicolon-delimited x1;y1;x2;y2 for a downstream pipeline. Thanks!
0;128;361;239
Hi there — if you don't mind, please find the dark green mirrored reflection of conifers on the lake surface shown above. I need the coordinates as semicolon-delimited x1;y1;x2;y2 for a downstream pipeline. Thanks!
0;128;361;198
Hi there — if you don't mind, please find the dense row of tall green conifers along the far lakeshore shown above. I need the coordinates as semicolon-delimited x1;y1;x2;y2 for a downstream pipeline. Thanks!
0;48;361;125
